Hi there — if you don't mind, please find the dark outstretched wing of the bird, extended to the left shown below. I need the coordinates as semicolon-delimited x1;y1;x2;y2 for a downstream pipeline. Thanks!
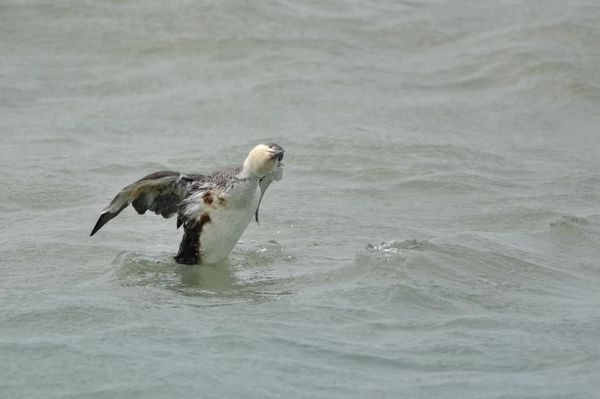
90;171;204;236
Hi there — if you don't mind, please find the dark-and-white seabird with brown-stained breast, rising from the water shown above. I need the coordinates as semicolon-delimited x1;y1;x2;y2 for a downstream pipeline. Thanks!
90;143;285;265
